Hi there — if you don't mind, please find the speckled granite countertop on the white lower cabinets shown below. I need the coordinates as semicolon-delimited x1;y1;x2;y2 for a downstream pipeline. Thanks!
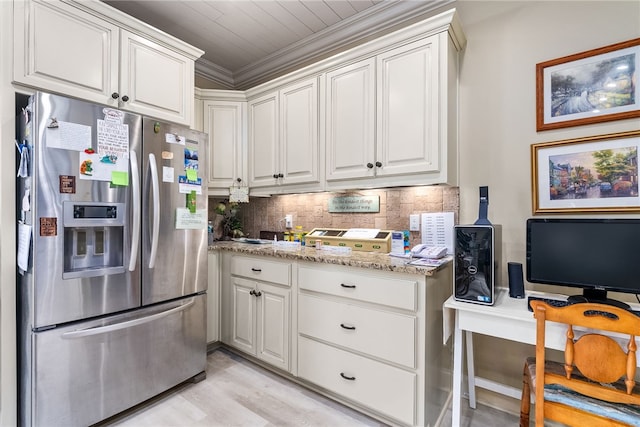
209;241;452;276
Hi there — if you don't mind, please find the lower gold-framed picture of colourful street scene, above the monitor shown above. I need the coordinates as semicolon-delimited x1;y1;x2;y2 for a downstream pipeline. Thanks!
531;131;640;214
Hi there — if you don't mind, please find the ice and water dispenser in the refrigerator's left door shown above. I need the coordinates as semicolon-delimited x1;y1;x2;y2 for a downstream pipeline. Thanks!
62;202;125;279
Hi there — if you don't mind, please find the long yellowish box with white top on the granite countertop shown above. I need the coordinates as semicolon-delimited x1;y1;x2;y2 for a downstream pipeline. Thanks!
305;228;392;253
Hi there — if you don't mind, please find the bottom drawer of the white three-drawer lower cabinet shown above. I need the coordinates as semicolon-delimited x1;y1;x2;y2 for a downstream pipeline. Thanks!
298;337;417;425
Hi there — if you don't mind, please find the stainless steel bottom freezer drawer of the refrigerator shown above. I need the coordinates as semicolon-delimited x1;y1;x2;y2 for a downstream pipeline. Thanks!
28;294;207;427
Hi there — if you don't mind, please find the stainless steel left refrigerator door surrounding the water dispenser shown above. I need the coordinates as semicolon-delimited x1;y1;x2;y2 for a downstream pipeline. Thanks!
27;93;142;328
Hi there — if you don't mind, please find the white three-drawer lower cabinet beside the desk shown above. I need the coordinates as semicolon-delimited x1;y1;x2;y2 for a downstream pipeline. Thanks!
297;263;452;426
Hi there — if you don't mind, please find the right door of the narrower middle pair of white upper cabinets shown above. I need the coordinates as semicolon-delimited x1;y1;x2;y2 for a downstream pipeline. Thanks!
279;77;319;184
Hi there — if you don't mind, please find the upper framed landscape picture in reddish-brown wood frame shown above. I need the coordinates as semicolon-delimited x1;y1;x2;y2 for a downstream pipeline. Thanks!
536;38;640;131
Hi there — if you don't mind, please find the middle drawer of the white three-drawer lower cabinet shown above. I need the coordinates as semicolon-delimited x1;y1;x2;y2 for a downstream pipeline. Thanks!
298;294;416;369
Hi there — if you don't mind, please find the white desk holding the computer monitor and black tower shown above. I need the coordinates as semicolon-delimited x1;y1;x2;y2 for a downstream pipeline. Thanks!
443;288;640;427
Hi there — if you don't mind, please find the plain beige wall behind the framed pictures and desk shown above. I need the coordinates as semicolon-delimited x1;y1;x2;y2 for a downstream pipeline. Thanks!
456;1;640;411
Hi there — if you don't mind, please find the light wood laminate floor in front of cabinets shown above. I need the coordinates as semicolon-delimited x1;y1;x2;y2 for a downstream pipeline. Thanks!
101;348;518;427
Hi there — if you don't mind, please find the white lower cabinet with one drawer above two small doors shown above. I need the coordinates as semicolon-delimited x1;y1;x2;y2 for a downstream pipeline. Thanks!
221;253;291;371
